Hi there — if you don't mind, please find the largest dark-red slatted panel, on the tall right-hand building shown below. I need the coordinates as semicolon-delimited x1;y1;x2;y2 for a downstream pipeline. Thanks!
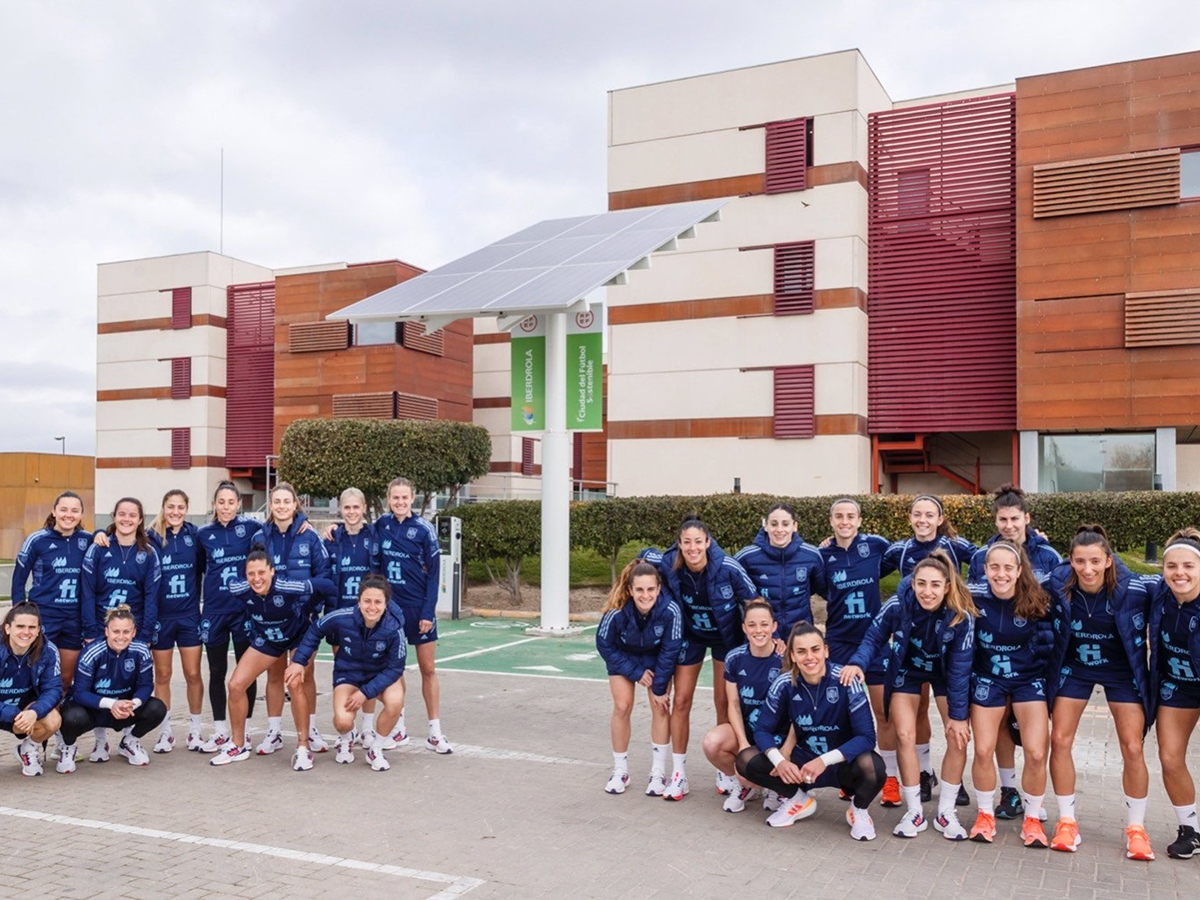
868;94;1016;433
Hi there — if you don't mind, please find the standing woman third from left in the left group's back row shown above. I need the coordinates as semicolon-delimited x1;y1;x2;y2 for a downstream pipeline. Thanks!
148;488;204;754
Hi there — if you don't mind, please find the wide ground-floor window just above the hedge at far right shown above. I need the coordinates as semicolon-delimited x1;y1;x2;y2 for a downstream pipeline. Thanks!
1038;433;1154;493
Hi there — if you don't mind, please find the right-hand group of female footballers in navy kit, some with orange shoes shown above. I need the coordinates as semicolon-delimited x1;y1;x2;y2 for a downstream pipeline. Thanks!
596;485;1200;860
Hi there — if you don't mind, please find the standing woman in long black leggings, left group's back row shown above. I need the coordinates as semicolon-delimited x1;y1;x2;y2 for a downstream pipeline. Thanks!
198;481;263;754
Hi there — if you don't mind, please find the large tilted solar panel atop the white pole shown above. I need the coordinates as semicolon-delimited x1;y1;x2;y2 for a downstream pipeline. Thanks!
326;199;727;322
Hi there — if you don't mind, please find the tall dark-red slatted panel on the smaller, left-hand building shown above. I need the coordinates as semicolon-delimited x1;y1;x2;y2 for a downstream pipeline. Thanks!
226;281;275;468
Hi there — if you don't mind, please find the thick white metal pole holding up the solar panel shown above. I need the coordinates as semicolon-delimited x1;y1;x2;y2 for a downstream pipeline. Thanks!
540;312;571;634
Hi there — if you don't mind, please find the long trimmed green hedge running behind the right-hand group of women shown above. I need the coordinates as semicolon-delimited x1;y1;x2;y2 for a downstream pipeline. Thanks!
451;491;1200;595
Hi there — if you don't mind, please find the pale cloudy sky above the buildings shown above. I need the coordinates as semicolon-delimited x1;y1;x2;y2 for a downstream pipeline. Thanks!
0;0;1200;454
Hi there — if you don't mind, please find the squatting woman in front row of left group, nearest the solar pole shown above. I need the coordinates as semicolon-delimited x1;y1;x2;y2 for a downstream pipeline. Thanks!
284;574;408;772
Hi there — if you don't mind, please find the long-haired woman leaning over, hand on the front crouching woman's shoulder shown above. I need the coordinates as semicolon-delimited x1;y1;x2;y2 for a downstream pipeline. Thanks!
841;550;976;840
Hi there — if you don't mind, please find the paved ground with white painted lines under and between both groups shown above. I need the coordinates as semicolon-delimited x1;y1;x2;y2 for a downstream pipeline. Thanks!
0;623;1200;900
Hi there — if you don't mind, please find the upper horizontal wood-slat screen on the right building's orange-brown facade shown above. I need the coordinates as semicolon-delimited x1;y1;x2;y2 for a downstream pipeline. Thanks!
1033;150;1180;218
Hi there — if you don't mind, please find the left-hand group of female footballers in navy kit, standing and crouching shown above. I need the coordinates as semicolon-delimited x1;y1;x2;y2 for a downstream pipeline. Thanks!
0;478;452;775
